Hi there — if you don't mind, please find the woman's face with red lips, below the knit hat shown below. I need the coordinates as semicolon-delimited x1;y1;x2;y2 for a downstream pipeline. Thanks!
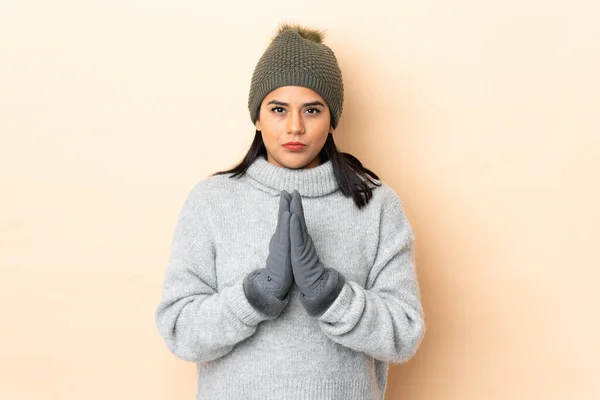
256;86;331;169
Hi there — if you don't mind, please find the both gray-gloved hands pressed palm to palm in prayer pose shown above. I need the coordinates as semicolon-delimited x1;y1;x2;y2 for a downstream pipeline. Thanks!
246;190;345;316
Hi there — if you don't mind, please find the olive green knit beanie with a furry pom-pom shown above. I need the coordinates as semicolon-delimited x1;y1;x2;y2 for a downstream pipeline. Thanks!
248;23;344;129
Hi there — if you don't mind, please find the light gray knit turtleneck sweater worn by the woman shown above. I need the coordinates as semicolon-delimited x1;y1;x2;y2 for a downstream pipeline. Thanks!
155;157;425;400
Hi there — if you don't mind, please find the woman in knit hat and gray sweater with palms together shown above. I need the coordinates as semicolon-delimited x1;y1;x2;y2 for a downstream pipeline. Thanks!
156;24;425;400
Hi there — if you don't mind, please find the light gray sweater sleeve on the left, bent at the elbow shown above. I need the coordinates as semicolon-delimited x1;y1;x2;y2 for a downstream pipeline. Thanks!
155;185;289;362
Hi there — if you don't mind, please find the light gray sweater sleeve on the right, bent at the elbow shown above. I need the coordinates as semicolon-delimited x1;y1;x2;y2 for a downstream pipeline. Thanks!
318;188;425;363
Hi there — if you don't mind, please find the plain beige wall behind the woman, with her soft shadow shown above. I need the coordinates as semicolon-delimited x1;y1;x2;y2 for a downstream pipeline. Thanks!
0;0;600;400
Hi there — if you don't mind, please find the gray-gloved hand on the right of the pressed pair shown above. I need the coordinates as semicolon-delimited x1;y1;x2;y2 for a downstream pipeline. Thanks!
290;190;345;316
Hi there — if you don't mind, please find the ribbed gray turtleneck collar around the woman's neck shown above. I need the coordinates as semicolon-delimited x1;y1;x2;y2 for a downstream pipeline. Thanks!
246;155;338;197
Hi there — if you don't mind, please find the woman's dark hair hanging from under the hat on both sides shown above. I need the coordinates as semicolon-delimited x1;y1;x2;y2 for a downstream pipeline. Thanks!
212;130;381;209
